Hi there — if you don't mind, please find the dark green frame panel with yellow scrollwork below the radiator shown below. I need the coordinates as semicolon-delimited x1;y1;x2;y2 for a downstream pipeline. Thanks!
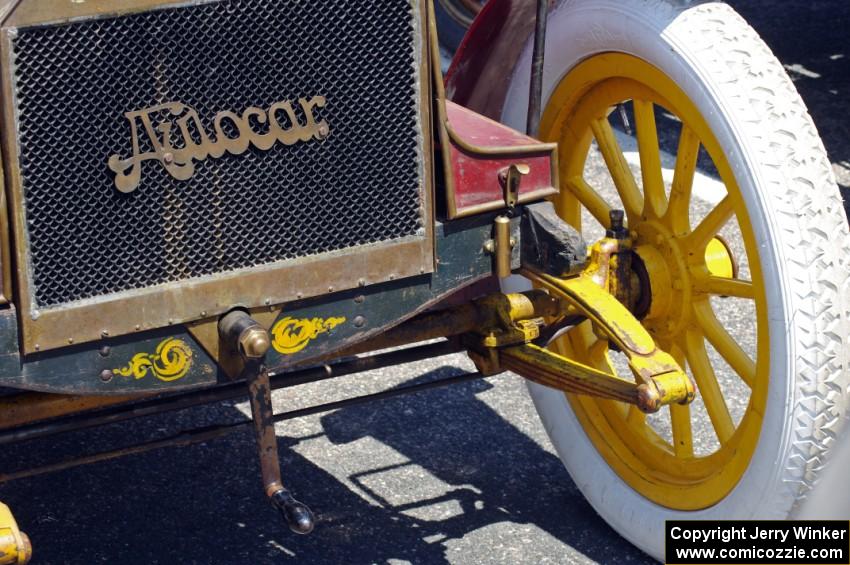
0;215;519;395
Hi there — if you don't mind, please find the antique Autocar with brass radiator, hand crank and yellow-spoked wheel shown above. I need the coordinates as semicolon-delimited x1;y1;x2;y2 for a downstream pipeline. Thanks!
0;0;850;564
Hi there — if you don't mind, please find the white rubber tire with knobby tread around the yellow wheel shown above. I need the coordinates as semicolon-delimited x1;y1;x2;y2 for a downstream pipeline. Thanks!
503;0;850;559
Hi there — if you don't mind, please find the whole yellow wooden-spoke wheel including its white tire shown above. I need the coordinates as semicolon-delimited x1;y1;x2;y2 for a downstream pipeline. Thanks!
496;0;850;558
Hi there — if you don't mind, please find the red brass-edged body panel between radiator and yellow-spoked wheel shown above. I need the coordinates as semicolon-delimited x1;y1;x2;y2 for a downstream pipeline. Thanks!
446;101;555;215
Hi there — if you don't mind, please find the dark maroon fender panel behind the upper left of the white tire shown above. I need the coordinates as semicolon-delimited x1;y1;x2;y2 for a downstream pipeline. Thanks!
446;0;540;120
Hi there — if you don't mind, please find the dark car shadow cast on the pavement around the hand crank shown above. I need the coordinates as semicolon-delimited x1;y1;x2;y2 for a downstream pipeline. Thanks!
0;367;644;564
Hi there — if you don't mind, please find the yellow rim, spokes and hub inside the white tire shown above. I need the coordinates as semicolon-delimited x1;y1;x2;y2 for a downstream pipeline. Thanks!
541;53;769;510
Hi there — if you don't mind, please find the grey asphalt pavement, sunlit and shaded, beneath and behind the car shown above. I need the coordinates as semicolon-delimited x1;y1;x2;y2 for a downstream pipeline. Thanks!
0;0;850;565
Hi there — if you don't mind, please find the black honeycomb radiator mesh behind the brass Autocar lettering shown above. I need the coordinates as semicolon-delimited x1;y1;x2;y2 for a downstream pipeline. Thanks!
13;0;422;306
